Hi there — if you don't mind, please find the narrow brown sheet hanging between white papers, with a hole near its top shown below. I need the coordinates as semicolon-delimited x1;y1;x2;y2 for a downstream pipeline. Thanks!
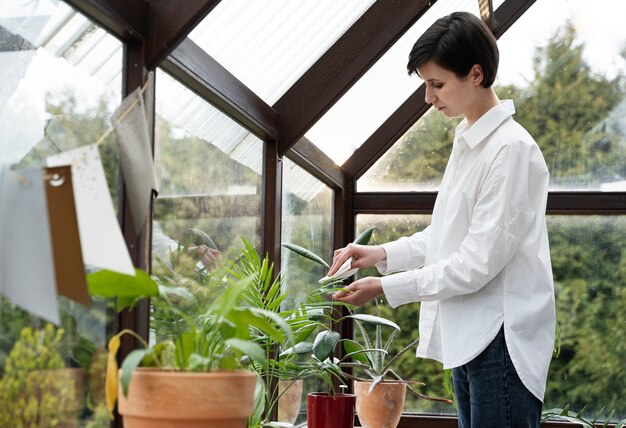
44;166;91;306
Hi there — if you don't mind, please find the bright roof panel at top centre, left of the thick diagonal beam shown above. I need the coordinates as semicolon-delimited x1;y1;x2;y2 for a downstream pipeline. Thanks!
189;0;374;105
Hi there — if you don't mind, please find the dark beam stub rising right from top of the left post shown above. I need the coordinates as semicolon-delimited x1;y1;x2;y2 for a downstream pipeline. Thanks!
146;0;220;69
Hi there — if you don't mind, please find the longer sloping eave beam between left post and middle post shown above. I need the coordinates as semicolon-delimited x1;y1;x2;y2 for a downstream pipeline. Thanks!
161;38;278;141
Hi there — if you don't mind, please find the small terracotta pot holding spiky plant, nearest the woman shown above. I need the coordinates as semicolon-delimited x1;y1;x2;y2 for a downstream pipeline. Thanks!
354;381;406;428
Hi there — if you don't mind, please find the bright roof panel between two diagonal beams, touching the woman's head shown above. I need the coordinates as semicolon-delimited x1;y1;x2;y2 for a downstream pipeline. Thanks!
306;0;479;165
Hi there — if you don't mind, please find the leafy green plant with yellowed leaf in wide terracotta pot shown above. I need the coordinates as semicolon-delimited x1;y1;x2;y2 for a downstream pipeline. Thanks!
88;241;293;428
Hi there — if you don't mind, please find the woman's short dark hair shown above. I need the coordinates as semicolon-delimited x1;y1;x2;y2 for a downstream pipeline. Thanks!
407;12;500;88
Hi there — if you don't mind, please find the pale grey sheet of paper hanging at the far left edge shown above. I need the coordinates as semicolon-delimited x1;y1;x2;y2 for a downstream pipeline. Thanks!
0;167;59;324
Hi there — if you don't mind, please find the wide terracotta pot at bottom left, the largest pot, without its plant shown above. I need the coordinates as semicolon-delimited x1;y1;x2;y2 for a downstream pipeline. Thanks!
118;369;257;428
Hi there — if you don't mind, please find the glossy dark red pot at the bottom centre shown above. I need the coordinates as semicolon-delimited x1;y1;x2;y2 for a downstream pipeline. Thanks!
306;392;356;428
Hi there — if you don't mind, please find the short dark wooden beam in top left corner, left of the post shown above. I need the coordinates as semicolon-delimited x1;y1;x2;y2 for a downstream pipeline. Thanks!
65;0;148;41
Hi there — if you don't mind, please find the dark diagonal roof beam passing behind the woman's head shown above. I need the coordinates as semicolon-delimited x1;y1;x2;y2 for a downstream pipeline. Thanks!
342;0;535;180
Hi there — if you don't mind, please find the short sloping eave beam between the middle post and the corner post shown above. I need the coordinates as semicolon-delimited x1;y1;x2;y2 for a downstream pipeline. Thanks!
286;137;346;189
